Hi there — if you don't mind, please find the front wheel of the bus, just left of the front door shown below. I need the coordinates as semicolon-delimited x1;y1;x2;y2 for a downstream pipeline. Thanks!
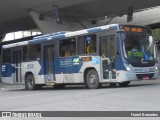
85;70;100;89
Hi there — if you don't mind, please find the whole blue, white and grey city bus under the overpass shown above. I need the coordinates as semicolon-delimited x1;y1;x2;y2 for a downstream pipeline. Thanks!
1;24;158;90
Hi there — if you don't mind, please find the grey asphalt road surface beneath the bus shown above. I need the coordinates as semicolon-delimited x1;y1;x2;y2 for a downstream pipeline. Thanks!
0;79;160;120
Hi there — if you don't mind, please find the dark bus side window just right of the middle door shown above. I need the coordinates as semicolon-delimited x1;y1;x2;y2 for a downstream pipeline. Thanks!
59;38;76;57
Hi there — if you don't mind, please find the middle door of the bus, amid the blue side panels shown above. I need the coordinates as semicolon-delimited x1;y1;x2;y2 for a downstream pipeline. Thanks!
44;45;55;82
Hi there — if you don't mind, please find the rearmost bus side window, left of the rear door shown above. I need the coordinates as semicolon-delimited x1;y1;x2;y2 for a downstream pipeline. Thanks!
3;49;11;63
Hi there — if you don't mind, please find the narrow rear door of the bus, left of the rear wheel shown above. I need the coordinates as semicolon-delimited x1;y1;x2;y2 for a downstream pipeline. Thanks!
13;50;22;83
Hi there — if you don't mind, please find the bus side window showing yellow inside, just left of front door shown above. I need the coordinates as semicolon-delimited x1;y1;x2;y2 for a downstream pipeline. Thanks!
78;34;96;54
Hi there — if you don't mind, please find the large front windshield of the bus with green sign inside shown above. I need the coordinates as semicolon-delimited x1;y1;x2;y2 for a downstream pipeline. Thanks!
123;26;156;67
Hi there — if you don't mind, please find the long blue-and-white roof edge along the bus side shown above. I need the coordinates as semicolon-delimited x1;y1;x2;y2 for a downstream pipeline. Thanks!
2;24;119;49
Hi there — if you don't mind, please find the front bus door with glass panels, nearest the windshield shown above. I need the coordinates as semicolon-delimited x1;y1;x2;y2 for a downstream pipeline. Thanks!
100;35;116;81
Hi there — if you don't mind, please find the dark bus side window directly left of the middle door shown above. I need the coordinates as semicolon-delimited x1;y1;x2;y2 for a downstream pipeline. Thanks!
29;44;41;60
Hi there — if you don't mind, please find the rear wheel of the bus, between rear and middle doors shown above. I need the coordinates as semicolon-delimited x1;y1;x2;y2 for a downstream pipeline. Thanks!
25;74;36;90
